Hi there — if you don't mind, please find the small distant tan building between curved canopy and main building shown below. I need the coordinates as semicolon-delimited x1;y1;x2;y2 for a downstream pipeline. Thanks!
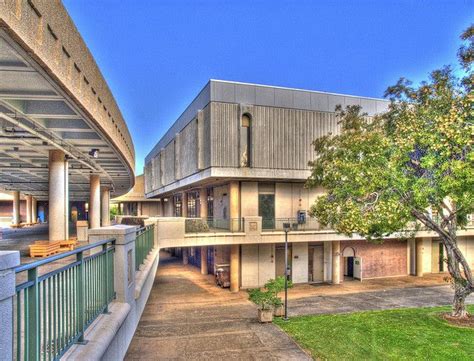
111;174;163;217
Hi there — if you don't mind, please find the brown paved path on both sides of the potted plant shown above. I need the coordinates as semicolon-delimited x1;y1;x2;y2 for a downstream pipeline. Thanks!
126;255;474;360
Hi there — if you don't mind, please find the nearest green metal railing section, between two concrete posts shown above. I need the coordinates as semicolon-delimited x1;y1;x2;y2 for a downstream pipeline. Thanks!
14;239;115;360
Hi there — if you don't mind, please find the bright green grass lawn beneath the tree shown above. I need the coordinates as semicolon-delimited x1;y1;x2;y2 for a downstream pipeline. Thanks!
275;306;474;360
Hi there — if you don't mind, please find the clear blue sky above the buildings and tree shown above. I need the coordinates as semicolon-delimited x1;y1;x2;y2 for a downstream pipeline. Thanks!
63;0;474;174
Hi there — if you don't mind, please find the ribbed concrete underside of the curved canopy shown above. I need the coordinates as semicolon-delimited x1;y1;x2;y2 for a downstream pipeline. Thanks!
0;31;133;200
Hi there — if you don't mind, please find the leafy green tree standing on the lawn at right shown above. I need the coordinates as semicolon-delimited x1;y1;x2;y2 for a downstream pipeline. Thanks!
307;26;474;317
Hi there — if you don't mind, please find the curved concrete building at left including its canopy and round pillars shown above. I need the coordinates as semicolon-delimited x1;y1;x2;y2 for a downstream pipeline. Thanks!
0;0;135;240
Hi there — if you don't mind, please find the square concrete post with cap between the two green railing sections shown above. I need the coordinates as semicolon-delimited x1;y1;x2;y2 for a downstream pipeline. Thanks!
89;224;136;307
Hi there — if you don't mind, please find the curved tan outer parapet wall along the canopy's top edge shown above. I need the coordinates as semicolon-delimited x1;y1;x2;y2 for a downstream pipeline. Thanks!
0;0;135;169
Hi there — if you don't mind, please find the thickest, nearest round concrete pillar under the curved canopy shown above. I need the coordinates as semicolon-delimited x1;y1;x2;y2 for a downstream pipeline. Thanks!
48;150;69;241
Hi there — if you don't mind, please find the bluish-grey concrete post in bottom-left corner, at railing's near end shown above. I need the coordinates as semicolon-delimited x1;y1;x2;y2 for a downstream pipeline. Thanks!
0;251;20;360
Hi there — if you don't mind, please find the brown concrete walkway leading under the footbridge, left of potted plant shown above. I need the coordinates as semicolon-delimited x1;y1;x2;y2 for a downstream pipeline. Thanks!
125;254;310;360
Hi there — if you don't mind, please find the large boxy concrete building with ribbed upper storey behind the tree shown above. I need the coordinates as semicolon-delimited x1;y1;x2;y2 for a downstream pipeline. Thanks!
145;80;474;290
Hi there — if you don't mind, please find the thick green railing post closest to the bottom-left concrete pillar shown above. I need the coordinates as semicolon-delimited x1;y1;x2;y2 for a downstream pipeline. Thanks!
25;268;41;360
